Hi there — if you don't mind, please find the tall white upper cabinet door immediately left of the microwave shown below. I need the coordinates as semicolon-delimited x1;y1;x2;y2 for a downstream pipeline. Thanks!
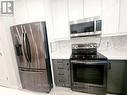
52;0;70;40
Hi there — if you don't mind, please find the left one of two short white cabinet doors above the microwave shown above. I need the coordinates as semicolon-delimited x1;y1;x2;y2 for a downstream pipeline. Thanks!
68;0;84;21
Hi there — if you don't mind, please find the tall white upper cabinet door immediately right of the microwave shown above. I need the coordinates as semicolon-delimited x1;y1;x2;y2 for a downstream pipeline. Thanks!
102;0;119;34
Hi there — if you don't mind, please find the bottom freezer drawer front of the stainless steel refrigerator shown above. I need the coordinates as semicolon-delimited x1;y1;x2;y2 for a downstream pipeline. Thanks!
19;70;50;92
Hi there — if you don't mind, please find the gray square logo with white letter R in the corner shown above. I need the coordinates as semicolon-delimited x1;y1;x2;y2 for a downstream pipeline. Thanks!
1;1;14;15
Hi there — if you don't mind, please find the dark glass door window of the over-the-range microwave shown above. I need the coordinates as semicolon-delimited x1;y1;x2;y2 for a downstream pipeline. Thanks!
70;21;94;34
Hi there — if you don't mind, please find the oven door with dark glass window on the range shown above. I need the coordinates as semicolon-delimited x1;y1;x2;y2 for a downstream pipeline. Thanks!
71;61;107;87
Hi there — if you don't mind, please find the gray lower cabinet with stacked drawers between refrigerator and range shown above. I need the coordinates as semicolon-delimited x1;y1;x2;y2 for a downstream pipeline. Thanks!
52;59;70;87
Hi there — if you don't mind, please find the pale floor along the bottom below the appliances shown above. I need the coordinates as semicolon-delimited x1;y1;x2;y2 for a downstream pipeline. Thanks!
0;86;116;95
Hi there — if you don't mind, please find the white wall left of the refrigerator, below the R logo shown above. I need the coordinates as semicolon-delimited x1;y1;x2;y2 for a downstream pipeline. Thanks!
0;16;20;88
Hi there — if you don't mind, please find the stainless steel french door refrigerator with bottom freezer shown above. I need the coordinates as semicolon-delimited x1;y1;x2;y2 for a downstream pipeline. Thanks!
10;22;52;92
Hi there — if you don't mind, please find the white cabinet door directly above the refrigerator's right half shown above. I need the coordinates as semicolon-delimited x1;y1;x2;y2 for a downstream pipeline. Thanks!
26;0;47;22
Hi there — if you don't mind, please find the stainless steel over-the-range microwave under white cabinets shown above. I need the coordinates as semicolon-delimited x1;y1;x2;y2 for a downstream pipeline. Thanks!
70;17;102;38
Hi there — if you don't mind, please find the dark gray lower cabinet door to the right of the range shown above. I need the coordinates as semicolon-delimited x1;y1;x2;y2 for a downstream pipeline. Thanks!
107;60;127;95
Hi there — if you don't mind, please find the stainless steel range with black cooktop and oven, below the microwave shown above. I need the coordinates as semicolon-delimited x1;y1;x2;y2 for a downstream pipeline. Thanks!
70;43;108;95
